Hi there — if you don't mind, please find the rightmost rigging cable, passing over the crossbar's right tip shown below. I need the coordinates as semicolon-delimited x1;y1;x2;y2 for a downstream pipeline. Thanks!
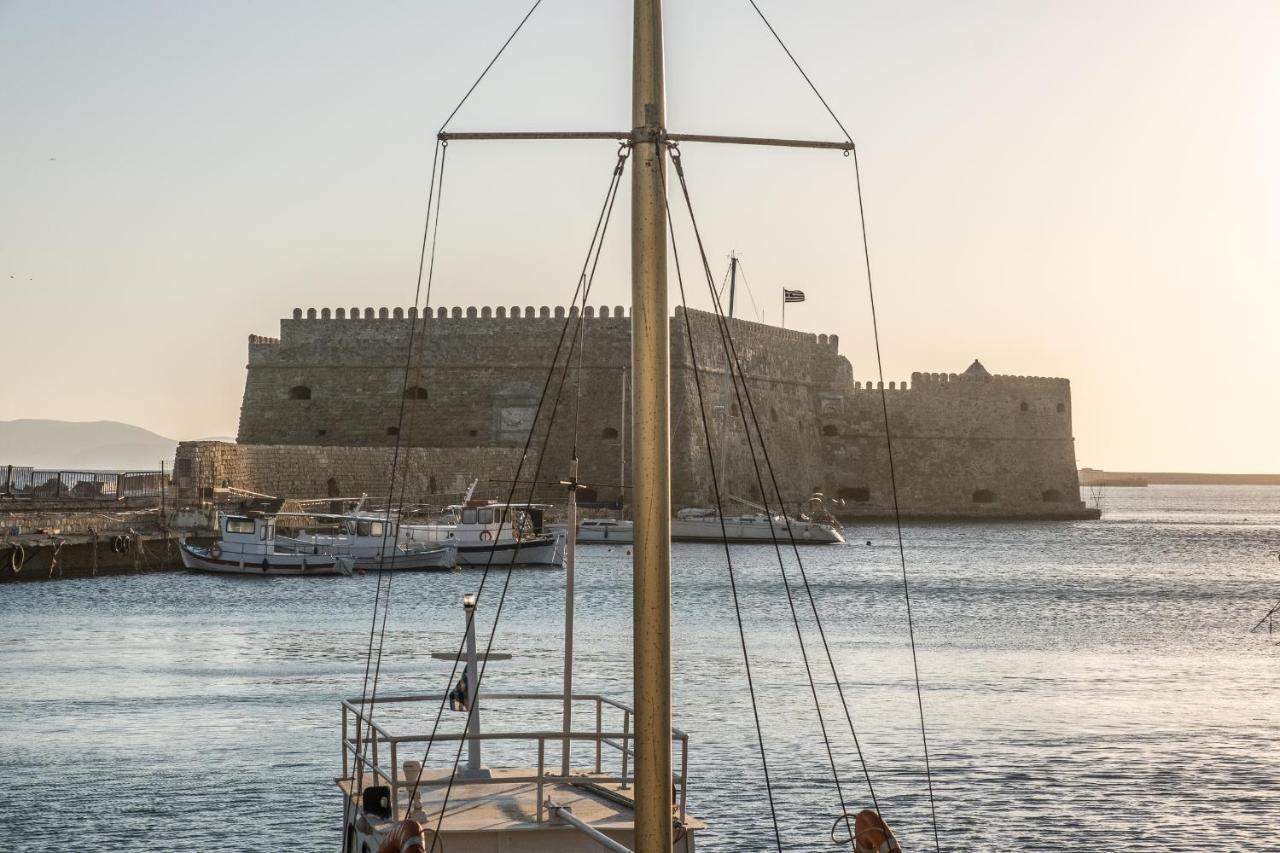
748;0;942;850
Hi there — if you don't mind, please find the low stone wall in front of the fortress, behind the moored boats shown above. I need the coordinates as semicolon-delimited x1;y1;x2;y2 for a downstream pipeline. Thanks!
174;442;535;503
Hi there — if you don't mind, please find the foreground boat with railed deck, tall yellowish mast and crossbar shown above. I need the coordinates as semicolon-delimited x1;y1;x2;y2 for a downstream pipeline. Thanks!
337;0;900;853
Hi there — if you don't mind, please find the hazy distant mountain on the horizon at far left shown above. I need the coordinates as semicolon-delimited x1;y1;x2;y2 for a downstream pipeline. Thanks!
0;419;178;471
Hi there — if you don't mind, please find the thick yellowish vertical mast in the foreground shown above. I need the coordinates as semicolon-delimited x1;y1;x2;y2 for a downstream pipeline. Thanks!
631;0;672;853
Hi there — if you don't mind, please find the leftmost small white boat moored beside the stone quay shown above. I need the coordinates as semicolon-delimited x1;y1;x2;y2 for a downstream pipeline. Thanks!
178;514;355;576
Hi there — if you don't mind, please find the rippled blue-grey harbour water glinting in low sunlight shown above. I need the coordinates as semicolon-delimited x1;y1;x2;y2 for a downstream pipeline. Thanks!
0;487;1280;850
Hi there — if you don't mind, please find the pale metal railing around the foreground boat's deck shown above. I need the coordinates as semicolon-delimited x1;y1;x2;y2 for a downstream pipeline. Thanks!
342;693;689;822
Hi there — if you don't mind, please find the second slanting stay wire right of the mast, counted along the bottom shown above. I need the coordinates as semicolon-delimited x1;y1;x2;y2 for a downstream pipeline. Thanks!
671;147;849;813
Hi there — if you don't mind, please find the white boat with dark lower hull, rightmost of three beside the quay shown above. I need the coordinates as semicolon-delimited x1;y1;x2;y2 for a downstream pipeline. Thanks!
399;501;568;566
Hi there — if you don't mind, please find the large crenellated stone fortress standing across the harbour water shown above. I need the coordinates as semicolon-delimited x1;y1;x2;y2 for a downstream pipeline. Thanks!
174;306;1096;519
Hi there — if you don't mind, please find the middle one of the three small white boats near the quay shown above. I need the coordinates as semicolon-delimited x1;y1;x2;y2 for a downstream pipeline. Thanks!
275;512;458;571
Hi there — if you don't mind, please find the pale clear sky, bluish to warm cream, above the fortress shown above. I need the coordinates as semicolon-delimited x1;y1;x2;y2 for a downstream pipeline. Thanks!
0;0;1280;473
